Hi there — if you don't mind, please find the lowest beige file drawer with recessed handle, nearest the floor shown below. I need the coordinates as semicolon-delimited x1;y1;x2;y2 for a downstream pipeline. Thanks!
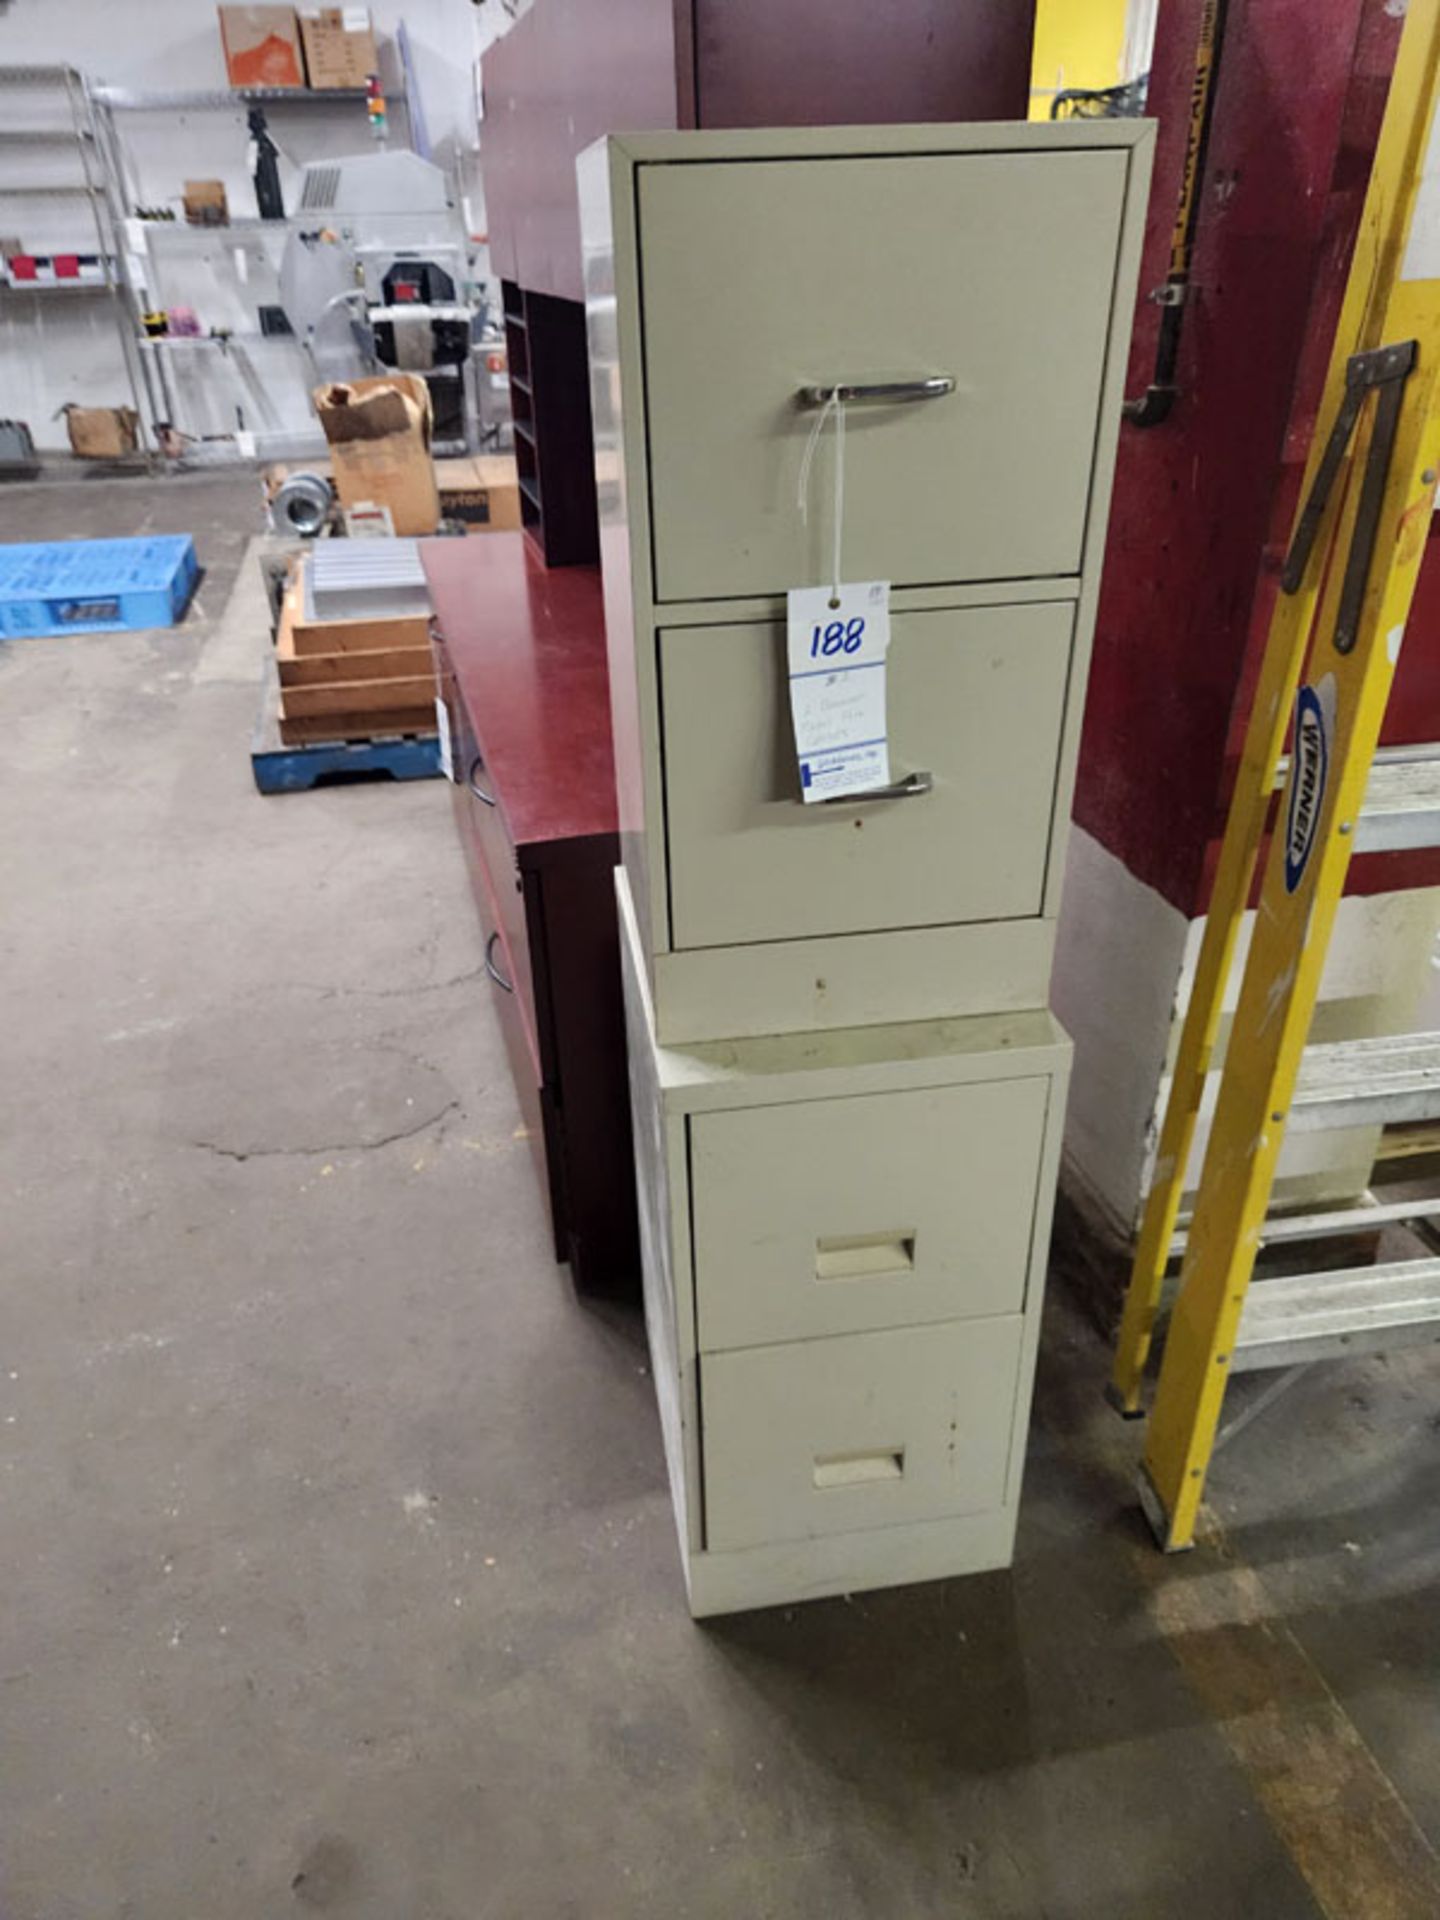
701;1315;1023;1551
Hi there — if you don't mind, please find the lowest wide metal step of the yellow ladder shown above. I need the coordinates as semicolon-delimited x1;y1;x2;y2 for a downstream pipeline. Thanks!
1231;1258;1440;1373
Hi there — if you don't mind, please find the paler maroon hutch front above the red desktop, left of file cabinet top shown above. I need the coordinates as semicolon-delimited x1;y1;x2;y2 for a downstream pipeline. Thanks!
480;0;678;300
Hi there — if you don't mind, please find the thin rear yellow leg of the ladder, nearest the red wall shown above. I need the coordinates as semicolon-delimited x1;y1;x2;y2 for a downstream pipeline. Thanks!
1106;0;1436;1419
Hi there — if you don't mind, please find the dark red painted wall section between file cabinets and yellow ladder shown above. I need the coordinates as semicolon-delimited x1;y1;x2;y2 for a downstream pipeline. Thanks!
1075;0;1384;914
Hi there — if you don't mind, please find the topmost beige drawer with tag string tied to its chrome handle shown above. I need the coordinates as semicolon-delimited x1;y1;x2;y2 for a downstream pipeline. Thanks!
637;148;1127;601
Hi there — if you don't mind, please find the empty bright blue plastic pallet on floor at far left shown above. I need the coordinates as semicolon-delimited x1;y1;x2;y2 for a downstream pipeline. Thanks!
0;534;200;639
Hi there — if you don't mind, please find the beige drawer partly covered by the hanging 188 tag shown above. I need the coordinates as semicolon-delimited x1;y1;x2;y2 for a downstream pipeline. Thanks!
659;601;1075;948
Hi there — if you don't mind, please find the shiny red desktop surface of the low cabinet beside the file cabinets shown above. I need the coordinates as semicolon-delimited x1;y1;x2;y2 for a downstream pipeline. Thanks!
420;534;618;847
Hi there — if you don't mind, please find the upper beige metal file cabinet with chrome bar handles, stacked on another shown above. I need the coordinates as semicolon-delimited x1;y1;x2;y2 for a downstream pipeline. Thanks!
580;121;1152;1044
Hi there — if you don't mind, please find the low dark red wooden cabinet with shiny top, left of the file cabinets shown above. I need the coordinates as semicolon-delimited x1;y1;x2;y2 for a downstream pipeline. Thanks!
424;534;639;1296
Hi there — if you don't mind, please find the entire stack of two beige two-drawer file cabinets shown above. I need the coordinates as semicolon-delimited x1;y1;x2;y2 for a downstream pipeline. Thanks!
580;121;1152;1615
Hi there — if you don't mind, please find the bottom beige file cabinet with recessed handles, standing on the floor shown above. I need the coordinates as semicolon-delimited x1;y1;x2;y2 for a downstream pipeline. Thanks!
616;870;1069;1615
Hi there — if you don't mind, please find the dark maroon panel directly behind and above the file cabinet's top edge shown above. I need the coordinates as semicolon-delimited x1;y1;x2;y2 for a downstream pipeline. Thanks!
693;0;1035;127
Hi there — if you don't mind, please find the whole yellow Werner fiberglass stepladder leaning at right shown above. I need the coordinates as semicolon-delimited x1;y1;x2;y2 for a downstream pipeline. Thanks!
1110;0;1440;1551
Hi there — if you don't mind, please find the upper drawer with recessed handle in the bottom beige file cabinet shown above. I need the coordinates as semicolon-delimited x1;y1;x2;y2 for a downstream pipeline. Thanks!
691;1077;1050;1352
